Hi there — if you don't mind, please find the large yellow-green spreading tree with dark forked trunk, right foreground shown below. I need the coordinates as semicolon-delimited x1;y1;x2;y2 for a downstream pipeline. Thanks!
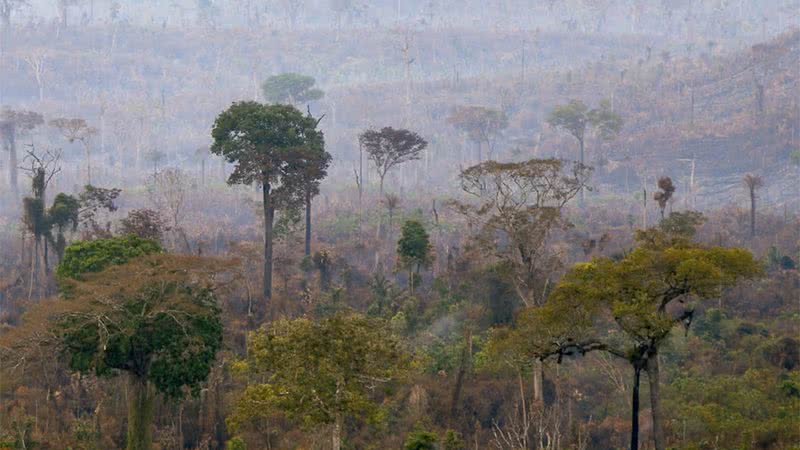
514;229;760;450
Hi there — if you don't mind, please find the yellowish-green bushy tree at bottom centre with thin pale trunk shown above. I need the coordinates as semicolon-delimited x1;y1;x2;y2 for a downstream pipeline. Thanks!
228;313;407;450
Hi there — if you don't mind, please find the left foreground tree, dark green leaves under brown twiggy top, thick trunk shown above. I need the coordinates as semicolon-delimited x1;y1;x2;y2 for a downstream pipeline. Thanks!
54;253;227;450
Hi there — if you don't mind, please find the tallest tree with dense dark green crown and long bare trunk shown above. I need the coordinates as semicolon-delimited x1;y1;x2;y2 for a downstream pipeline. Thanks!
211;102;324;299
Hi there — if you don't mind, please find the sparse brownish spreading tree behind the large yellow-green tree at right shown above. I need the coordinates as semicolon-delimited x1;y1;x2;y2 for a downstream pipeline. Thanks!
452;159;590;402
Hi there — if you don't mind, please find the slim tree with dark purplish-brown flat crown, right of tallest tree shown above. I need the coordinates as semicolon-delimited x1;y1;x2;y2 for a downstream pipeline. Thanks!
358;127;428;198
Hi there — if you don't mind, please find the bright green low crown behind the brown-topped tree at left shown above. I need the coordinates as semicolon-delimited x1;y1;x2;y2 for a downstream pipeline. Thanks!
56;235;162;280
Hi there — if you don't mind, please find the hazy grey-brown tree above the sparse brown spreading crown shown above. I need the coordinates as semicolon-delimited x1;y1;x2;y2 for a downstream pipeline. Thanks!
447;106;508;163
